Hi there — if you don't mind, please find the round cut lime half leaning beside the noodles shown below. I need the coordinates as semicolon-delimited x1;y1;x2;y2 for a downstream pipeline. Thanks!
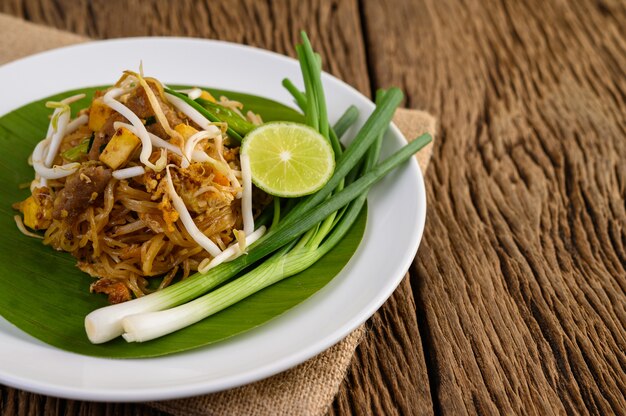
241;122;335;197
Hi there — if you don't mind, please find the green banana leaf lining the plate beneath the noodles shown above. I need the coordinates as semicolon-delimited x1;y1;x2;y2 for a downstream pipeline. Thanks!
0;87;366;358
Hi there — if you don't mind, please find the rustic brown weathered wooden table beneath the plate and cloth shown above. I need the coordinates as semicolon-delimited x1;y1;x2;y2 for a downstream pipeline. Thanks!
0;0;626;415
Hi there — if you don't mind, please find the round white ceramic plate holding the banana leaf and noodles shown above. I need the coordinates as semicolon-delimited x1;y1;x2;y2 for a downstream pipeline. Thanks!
0;38;426;401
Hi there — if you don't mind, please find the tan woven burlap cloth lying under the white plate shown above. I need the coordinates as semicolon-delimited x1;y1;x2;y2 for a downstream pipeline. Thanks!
0;14;435;415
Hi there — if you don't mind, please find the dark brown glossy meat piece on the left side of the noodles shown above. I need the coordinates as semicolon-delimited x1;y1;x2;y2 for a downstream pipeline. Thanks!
52;165;111;220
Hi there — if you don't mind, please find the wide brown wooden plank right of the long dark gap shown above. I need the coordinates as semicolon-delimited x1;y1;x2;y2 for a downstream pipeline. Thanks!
358;1;626;415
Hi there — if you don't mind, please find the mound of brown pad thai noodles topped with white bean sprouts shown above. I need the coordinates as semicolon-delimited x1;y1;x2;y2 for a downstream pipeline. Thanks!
15;71;270;303
